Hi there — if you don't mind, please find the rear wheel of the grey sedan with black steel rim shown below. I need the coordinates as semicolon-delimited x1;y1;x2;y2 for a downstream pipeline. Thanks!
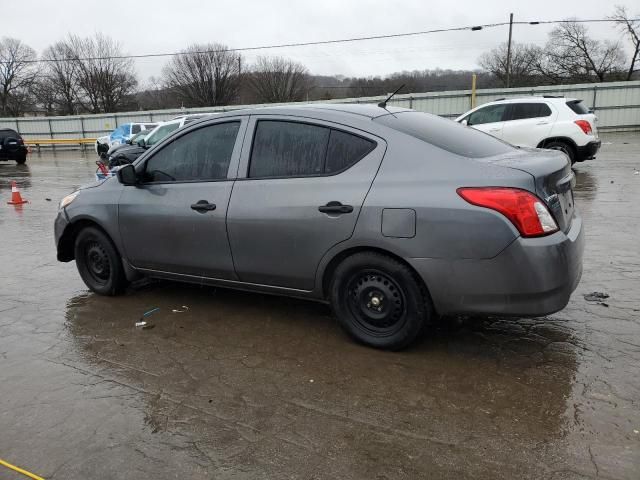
330;252;433;350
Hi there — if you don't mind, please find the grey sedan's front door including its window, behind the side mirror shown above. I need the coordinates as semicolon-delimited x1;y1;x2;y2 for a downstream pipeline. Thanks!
118;119;246;279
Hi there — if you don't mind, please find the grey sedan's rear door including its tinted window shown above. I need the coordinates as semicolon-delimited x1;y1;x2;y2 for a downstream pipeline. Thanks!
227;115;386;290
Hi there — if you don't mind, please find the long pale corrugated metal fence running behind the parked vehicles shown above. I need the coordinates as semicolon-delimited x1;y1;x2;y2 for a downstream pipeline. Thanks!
0;81;640;140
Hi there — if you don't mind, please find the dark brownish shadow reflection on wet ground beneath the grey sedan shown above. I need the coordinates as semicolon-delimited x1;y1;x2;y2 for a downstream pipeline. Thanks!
66;282;577;462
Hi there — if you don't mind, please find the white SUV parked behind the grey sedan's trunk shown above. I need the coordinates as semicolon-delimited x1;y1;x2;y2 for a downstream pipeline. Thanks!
456;96;600;163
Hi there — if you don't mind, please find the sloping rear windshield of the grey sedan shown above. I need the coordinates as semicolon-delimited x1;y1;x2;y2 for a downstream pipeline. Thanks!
375;112;515;158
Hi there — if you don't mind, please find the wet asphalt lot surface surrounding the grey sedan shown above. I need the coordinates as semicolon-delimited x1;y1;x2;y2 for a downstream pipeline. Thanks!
0;133;640;480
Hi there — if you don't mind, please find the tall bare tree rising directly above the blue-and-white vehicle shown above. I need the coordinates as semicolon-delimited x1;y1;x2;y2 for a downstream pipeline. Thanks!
66;33;138;113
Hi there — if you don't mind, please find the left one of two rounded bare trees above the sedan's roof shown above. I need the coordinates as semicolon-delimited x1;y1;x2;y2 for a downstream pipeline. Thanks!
162;43;242;107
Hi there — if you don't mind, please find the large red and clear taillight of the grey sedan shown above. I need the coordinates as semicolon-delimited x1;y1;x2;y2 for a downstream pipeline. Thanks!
457;187;558;237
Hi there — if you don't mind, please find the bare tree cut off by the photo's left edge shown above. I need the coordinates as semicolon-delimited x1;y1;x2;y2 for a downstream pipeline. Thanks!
0;37;38;115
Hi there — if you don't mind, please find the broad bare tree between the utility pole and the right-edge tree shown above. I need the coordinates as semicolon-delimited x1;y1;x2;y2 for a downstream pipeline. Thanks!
538;21;623;82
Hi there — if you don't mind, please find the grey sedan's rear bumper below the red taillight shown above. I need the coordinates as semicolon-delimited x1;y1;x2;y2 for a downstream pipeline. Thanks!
408;216;584;316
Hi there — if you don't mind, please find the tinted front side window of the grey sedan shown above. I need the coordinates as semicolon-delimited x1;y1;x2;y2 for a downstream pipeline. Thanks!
144;122;240;182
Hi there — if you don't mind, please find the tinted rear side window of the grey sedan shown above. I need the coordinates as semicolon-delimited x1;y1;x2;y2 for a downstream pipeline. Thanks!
249;120;376;178
